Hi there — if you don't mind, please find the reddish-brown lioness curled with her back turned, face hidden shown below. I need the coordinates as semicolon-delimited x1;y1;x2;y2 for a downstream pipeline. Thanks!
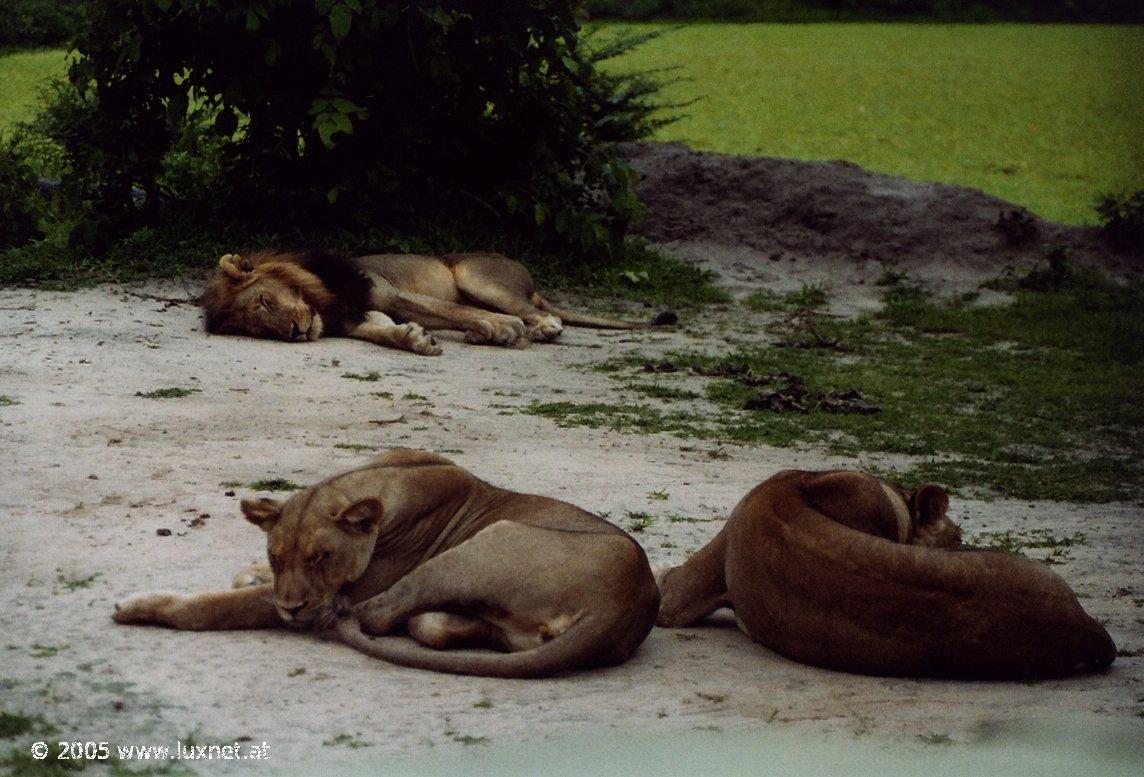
657;470;1117;679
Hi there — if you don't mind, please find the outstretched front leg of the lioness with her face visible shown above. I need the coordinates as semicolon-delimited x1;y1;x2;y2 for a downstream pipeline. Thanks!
111;584;283;632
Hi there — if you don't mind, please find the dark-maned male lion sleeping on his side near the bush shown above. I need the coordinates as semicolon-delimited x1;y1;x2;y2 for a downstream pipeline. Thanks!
202;251;676;356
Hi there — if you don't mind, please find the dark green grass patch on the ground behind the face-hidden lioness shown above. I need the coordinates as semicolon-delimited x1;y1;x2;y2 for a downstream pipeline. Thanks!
524;278;1144;501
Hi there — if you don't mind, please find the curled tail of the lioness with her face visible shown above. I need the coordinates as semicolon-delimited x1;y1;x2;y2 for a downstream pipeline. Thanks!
334;616;607;677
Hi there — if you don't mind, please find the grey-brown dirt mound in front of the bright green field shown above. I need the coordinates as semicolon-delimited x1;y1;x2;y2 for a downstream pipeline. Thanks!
625;143;1144;291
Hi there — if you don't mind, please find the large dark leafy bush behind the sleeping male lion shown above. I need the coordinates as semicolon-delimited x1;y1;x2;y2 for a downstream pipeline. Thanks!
46;0;656;256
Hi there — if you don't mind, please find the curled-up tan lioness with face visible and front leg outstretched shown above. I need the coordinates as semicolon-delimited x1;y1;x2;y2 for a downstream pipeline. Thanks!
113;450;659;677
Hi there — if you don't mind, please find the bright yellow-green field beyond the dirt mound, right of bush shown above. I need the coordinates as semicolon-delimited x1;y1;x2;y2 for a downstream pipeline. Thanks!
614;24;1144;223
